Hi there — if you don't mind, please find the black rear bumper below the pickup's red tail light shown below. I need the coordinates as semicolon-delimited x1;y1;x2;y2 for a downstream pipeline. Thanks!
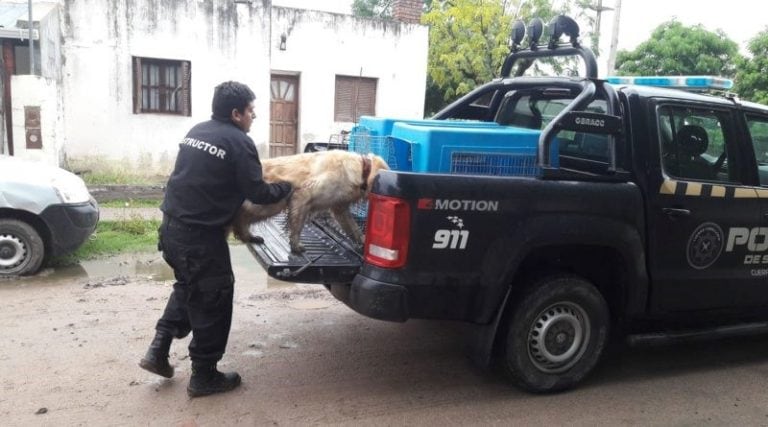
329;274;410;322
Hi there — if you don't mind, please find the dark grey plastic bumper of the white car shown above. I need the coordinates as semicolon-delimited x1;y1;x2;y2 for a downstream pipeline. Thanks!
40;199;99;256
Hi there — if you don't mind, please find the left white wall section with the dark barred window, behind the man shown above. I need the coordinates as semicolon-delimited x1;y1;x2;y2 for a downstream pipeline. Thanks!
62;0;269;173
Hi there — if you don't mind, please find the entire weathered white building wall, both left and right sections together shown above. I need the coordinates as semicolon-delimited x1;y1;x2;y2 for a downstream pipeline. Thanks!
11;0;428;174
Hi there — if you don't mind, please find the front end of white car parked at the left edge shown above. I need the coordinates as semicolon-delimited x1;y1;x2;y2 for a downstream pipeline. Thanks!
0;156;99;277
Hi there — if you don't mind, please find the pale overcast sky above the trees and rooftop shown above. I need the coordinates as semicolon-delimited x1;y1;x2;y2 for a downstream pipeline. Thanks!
273;0;768;73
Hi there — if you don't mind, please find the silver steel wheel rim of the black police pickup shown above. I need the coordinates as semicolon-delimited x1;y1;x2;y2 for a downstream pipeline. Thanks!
528;302;590;373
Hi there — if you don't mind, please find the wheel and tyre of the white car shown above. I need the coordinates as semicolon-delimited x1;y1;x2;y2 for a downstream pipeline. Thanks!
0;219;45;277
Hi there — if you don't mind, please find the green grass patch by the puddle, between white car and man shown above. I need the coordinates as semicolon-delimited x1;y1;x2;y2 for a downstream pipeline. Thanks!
50;217;160;266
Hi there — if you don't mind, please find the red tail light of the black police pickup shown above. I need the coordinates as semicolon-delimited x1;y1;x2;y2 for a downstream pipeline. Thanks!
365;194;411;268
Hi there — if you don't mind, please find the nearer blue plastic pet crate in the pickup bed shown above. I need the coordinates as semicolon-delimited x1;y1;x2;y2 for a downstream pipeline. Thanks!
392;122;559;176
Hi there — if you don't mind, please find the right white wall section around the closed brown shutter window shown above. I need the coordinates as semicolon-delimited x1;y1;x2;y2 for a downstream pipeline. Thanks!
266;7;428;146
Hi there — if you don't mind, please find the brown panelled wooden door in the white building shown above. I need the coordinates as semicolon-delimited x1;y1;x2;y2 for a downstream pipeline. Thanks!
269;74;299;157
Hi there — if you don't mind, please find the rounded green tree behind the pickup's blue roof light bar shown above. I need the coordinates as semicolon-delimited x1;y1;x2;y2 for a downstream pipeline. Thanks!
616;19;740;77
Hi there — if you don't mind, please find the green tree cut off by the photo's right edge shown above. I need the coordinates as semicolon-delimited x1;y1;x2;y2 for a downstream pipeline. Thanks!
735;29;768;104
